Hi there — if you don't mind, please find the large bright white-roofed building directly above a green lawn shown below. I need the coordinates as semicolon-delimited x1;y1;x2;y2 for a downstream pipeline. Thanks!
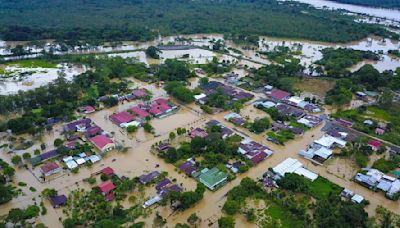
272;158;318;181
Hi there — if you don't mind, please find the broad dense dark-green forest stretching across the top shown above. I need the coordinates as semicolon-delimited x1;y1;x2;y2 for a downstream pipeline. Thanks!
0;0;388;42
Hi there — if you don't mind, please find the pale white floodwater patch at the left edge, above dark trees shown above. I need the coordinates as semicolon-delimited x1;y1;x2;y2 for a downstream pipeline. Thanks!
0;64;86;95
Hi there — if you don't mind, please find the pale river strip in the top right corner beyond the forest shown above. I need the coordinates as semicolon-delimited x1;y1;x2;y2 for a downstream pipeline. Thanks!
290;0;400;21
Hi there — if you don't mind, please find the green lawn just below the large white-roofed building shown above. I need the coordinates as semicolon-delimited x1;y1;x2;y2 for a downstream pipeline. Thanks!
309;176;343;199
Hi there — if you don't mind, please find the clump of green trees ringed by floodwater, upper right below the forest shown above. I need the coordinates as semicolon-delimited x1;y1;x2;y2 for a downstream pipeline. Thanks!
316;48;379;77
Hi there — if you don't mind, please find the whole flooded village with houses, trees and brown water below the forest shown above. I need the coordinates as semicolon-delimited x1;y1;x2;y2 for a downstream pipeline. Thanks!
0;1;400;228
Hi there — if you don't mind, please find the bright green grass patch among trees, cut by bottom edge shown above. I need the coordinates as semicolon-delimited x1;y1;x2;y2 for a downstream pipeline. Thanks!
265;201;301;228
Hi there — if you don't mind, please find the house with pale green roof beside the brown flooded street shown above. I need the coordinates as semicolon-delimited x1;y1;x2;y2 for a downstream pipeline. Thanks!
198;167;228;191
